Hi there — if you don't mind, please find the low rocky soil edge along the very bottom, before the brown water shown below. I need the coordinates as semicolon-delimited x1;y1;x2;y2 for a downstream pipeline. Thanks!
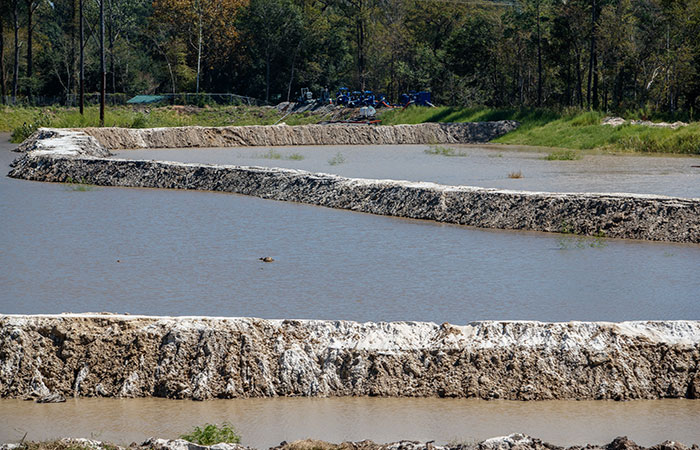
0;434;698;450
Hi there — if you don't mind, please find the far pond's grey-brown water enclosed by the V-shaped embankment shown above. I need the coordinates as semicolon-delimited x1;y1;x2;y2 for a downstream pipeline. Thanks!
116;145;700;198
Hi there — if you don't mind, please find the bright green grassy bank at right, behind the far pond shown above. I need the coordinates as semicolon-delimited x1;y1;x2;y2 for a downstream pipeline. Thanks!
382;107;700;155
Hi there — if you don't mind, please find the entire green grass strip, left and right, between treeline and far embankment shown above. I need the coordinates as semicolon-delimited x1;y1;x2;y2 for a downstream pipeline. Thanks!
0;106;700;155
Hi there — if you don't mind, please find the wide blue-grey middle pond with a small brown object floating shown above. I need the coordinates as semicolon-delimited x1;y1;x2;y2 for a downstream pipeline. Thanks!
0;139;700;324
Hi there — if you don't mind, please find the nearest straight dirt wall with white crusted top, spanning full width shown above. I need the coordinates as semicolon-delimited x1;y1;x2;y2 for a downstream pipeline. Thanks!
0;314;700;400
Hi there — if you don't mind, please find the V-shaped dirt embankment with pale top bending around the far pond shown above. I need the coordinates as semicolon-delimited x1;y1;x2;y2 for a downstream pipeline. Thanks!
9;121;700;243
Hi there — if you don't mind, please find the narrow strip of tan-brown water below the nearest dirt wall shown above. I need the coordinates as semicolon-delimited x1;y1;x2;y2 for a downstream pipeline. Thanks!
0;398;700;448
